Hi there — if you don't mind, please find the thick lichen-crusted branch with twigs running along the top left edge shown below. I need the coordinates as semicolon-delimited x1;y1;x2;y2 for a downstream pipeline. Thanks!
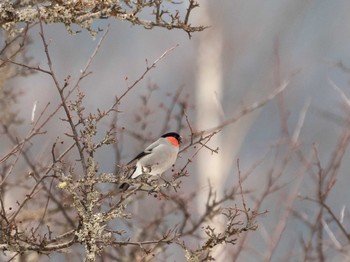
0;0;205;36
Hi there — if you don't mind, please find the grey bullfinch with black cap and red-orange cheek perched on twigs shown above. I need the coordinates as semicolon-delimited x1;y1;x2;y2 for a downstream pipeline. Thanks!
119;132;182;191
